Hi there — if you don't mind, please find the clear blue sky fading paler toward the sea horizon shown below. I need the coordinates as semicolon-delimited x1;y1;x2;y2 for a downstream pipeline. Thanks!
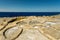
0;0;60;12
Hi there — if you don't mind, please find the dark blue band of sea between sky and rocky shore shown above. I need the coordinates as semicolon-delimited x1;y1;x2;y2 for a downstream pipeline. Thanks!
0;12;60;17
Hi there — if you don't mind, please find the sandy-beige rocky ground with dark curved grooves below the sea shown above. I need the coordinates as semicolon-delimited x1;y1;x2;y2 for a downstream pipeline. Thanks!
0;15;60;40
